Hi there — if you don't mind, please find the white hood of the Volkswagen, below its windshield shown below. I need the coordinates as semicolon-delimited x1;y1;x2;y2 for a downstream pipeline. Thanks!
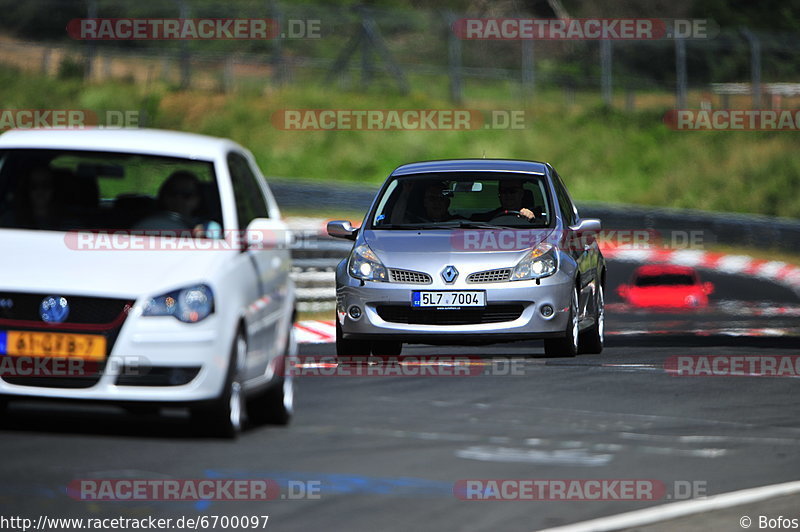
0;229;237;299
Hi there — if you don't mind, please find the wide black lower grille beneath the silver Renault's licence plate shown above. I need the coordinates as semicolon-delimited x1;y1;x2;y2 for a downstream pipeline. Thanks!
376;305;524;325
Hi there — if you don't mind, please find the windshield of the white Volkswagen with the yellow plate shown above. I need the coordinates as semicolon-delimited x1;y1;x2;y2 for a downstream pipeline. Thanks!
0;150;222;236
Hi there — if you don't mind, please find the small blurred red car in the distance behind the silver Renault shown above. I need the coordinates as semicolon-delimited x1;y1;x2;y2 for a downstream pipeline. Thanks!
617;264;714;308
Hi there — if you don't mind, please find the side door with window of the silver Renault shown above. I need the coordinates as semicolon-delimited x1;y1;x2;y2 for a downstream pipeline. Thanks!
552;169;599;318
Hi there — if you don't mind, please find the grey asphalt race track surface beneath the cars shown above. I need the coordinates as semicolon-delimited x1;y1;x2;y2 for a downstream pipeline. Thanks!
0;262;800;531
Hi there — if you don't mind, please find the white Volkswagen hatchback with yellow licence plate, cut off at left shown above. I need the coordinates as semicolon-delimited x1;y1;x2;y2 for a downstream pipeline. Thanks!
0;129;296;436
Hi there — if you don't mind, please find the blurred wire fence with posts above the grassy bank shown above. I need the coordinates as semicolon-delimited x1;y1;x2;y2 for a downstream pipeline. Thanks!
0;0;800;108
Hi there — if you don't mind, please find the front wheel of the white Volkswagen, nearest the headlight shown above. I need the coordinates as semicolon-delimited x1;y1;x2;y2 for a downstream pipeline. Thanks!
190;329;247;439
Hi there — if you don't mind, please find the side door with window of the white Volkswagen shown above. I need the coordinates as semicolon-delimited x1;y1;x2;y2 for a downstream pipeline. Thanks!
227;151;291;379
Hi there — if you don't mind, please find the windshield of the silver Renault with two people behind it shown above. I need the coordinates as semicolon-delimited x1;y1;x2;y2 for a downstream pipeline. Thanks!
370;172;552;229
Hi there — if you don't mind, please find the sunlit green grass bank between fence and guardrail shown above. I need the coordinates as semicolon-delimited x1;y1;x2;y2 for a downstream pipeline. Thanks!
0;64;800;217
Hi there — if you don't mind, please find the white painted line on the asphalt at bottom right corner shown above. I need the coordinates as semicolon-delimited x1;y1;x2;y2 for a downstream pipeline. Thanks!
539;481;800;532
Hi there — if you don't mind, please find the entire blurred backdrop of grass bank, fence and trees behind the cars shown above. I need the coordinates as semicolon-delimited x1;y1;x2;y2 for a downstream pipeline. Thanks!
0;0;800;218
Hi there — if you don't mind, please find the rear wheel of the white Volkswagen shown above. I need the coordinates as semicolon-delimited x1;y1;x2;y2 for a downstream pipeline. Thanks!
247;327;297;425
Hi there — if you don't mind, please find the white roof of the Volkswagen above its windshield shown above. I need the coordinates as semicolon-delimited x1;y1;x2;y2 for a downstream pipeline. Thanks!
0;128;243;160
